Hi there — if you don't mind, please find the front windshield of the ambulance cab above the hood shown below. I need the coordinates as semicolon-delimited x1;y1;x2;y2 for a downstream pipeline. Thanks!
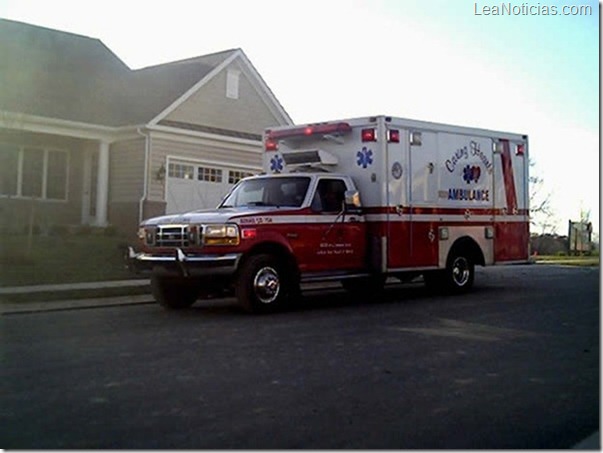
220;176;310;208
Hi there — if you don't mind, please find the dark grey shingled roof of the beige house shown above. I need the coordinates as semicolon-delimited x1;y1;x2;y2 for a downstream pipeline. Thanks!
0;19;286;126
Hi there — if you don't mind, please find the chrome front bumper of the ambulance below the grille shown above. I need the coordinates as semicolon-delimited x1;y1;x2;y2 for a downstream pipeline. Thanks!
126;247;241;277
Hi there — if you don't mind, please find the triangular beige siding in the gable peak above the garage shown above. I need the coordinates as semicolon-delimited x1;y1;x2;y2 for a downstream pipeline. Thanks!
166;62;281;134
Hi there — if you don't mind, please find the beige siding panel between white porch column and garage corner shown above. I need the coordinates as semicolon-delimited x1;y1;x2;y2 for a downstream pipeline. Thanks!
109;138;145;203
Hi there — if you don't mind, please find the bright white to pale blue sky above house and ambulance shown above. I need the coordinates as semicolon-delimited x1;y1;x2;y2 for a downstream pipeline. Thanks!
0;0;600;235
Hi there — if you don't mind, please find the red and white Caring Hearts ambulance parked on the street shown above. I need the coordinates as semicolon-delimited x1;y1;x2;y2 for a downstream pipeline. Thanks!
129;116;530;313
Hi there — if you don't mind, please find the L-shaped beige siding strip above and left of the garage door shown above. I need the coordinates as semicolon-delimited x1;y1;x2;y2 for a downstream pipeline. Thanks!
149;134;262;201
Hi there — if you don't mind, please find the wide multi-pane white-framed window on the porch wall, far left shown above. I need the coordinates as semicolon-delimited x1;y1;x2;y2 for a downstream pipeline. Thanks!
0;144;68;200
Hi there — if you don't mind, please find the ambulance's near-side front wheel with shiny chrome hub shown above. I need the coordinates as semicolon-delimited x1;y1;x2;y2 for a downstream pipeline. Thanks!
235;254;299;313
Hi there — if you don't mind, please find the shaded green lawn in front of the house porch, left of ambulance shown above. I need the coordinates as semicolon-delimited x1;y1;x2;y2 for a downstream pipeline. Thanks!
0;234;142;287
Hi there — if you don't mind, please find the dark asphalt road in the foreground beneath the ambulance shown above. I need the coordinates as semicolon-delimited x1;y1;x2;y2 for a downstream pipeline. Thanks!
0;265;600;449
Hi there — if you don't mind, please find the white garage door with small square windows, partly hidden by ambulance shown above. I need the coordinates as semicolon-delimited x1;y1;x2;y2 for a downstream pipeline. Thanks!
166;159;252;214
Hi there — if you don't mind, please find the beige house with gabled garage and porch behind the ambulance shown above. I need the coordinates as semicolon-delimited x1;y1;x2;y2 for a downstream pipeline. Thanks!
0;19;292;237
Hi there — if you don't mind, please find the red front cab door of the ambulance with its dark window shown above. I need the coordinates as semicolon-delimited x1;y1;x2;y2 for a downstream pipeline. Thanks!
307;177;366;271
